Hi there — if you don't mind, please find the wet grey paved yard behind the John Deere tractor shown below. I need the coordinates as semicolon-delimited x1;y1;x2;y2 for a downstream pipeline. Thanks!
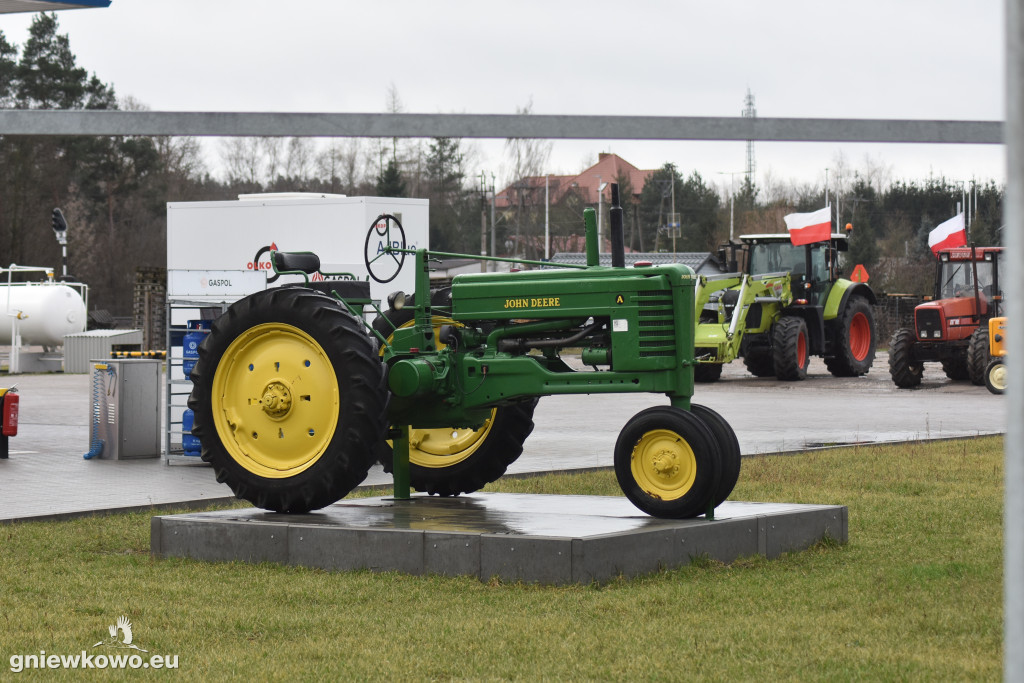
0;353;1007;522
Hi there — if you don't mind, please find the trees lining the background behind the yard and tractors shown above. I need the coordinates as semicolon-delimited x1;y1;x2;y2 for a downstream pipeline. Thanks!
0;13;1004;315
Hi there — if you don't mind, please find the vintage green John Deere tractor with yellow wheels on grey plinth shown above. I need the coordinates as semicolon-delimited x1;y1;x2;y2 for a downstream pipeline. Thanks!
188;185;740;518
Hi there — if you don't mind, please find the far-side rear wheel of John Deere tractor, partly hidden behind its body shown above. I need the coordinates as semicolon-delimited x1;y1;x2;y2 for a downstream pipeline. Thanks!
374;305;538;496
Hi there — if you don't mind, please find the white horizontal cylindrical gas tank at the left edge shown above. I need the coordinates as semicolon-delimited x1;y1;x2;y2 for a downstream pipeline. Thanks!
0;283;86;346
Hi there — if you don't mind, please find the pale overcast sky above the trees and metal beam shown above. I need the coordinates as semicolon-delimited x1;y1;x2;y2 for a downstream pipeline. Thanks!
0;0;1005;191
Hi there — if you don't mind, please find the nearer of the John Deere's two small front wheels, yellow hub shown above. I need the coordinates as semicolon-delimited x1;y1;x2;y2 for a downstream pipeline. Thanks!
614;405;722;519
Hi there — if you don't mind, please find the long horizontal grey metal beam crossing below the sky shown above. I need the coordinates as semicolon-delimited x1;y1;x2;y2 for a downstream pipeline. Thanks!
0;110;1004;144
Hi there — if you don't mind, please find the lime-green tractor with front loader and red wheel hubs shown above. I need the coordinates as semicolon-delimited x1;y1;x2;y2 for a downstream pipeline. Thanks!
693;229;876;382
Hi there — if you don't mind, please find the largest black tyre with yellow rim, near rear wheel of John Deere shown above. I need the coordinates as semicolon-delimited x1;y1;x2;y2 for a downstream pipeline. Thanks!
188;287;387;513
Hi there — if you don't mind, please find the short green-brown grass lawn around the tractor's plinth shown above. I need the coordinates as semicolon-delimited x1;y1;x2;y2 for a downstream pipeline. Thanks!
0;438;1002;681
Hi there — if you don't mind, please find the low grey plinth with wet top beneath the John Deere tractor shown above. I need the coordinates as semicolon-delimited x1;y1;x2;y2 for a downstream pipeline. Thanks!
151;493;847;584
